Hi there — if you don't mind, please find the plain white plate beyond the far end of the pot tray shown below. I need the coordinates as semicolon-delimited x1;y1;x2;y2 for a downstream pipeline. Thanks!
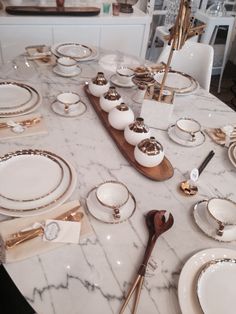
98;53;140;72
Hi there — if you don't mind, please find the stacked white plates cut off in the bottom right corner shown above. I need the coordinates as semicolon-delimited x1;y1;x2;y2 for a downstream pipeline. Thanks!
178;248;236;314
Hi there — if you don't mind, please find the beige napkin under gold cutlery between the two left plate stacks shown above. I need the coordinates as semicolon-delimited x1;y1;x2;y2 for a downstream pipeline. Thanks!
0;112;48;141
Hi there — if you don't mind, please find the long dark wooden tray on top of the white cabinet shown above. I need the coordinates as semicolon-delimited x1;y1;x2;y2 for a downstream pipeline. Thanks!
6;6;100;16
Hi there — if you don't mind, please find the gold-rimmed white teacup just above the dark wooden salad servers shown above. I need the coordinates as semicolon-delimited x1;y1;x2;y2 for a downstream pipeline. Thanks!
96;181;129;219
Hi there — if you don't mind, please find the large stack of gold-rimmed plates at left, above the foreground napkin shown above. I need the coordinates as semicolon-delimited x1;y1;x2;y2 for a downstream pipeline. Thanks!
0;150;76;217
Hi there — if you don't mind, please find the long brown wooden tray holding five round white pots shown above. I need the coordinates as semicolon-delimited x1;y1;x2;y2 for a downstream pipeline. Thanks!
84;85;174;181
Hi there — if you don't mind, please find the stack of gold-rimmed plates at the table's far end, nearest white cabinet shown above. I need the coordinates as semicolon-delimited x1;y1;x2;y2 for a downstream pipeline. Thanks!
51;43;98;61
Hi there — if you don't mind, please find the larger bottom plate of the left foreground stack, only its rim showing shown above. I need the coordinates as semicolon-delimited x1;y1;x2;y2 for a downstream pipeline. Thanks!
0;150;77;217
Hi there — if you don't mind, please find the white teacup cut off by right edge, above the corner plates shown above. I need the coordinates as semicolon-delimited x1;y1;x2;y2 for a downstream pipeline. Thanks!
207;198;236;236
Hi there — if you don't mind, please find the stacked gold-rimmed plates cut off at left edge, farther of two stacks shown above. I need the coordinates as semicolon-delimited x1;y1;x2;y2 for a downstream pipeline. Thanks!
0;82;42;118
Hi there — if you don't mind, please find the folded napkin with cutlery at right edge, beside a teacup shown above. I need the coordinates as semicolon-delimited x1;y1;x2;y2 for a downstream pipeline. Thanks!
205;125;236;147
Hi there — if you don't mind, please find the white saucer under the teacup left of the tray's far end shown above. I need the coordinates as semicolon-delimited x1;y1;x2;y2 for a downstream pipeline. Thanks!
51;100;87;117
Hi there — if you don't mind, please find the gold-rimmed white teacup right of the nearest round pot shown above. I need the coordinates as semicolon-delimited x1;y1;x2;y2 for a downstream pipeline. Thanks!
175;118;201;142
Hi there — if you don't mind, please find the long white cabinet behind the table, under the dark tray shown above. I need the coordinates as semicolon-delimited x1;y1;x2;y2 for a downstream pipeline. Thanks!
0;8;151;62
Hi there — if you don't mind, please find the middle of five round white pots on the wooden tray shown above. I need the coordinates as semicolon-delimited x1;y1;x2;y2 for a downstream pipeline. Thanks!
108;103;134;130
